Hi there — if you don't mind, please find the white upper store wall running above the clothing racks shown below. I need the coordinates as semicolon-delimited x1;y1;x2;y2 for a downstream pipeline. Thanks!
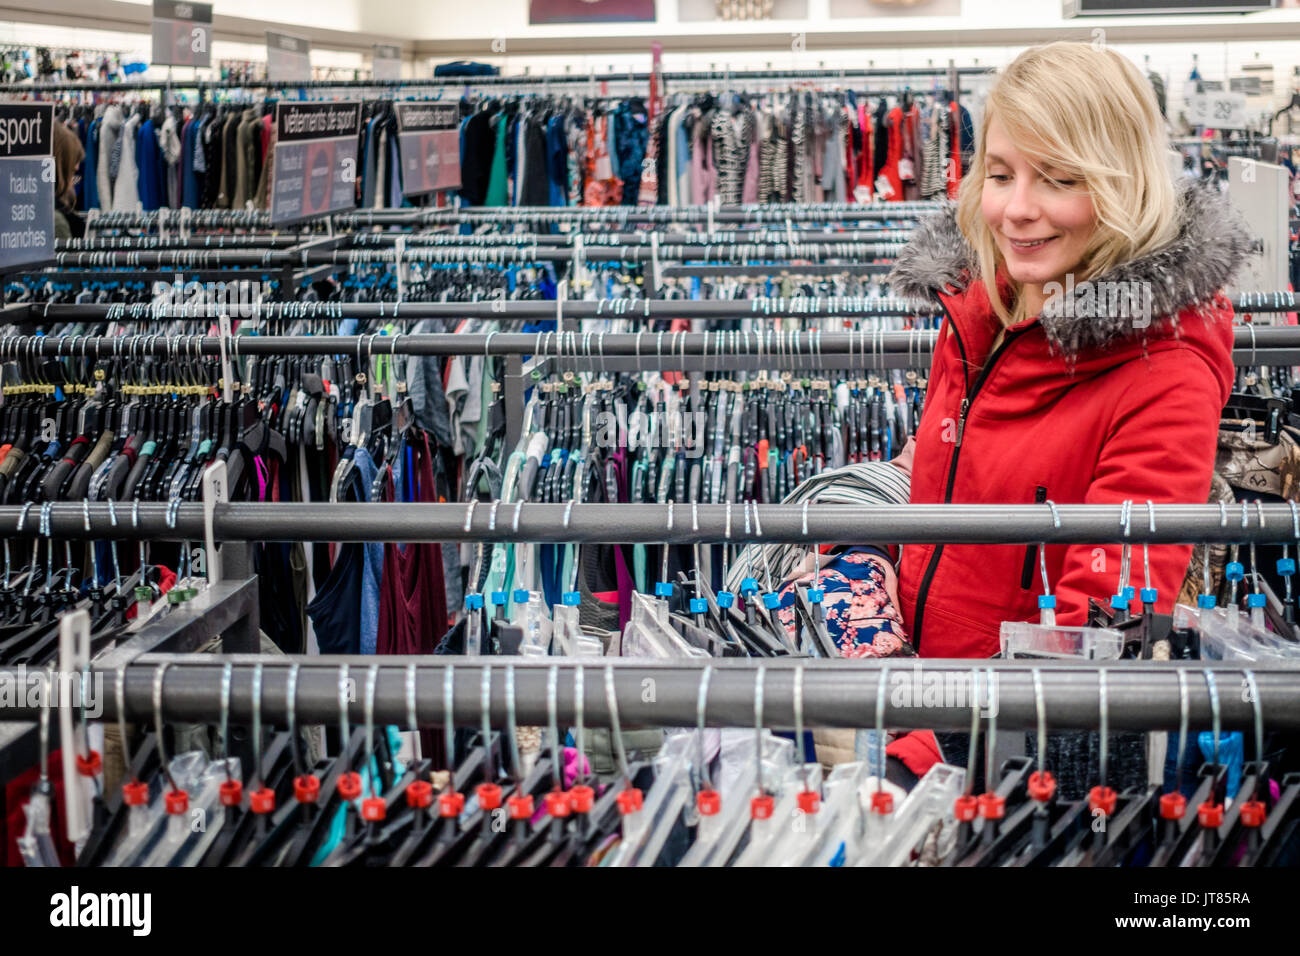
0;0;1300;115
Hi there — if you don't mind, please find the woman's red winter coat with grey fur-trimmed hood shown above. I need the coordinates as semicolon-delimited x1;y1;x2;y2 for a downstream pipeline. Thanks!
891;178;1249;658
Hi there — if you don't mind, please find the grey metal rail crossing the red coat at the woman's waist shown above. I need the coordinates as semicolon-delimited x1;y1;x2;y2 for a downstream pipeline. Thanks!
0;501;1300;546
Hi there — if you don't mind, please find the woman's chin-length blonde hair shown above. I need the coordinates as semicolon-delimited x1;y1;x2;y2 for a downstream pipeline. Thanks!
957;40;1178;325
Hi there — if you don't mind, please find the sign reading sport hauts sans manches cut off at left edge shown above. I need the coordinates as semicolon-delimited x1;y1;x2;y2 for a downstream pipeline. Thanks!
0;103;55;269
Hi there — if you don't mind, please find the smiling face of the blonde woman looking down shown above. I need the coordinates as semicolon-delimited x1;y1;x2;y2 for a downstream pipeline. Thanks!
982;117;1097;306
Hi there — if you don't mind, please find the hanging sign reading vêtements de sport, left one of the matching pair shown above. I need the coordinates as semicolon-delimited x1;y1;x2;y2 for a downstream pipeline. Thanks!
270;103;361;225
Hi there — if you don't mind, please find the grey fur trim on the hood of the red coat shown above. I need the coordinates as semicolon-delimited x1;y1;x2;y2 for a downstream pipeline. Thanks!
889;178;1256;355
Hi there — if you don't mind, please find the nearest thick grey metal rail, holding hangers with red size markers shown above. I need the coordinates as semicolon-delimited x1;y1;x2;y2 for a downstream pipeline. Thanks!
0;654;1300;731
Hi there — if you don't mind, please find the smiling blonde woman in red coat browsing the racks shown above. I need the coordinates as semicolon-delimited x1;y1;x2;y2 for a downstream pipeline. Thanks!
891;43;1251;658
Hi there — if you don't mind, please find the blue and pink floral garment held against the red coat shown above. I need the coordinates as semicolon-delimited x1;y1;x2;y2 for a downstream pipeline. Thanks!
776;548;915;657
